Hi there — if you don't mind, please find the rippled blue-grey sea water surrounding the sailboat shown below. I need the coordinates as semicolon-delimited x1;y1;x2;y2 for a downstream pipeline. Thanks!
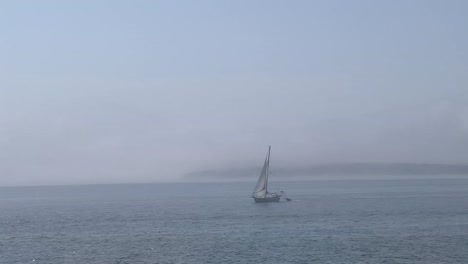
0;179;468;264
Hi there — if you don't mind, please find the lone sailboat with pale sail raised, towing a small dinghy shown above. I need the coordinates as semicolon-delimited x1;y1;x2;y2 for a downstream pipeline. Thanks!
252;146;283;203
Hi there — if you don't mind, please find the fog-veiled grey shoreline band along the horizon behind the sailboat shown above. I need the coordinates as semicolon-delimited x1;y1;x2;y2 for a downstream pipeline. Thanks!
0;163;468;188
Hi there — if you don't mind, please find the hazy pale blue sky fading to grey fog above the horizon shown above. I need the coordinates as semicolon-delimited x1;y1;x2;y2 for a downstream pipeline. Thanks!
0;0;468;186
